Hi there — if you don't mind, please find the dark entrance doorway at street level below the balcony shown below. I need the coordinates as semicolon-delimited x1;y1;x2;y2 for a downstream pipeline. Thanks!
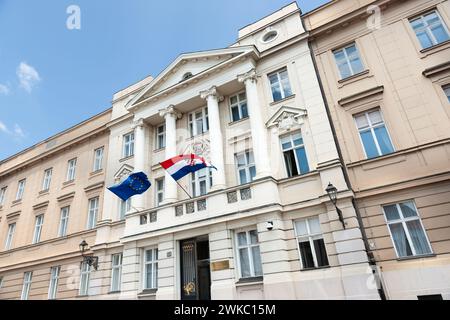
180;238;211;300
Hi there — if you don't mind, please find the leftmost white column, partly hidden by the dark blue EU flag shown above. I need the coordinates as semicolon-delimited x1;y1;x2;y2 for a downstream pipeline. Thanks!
131;118;149;211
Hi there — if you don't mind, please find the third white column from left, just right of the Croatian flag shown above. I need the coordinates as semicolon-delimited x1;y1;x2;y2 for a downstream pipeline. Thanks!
200;86;226;190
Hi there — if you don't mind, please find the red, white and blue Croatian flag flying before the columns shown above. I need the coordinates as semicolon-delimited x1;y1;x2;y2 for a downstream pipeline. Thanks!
160;153;217;181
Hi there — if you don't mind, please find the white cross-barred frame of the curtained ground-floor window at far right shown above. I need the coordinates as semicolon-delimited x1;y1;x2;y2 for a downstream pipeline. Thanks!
381;200;434;259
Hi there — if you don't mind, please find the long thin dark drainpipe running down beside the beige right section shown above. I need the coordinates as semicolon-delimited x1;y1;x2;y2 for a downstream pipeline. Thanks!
300;15;386;300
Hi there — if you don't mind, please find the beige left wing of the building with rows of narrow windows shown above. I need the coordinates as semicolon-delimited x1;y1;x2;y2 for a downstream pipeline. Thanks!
0;110;111;300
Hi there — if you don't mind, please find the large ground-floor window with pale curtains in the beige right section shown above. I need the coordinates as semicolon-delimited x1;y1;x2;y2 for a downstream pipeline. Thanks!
383;201;432;258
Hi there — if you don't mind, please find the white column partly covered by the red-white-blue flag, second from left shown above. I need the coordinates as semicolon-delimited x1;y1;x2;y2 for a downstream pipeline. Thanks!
159;105;181;203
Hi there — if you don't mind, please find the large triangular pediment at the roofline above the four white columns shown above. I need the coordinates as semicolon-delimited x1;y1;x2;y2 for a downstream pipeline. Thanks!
127;46;259;108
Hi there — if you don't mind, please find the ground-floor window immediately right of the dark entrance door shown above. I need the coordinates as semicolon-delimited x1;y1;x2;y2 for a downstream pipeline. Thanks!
237;230;262;278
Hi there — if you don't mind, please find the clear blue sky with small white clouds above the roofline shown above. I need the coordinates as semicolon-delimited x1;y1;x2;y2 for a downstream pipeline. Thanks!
0;0;327;159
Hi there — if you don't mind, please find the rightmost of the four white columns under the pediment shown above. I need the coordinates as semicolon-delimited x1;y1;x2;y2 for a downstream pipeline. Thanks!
238;69;272;179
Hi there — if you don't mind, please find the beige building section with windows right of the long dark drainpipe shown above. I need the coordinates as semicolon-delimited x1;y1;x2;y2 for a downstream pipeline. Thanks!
304;0;450;299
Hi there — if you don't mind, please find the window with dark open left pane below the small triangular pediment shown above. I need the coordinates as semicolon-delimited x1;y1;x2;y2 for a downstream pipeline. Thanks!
281;132;309;177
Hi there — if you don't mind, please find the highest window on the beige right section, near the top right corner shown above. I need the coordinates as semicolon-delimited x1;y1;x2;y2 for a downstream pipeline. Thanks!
409;10;450;49
